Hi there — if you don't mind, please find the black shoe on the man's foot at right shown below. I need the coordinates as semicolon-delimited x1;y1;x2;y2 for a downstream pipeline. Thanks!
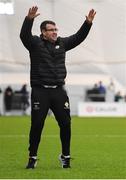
59;155;71;168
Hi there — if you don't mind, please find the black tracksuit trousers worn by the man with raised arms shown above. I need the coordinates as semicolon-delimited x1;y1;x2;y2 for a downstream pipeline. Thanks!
29;86;71;156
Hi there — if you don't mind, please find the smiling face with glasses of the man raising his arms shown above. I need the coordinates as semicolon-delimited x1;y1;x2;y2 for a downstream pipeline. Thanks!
42;24;58;42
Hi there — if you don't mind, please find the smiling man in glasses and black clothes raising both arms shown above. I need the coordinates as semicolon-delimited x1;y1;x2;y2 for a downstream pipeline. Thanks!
20;6;96;169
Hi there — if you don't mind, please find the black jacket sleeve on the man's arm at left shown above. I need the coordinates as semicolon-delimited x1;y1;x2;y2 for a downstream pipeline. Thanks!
20;17;34;50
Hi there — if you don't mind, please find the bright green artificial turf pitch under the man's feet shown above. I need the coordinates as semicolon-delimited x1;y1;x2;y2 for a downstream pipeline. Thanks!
0;116;126;179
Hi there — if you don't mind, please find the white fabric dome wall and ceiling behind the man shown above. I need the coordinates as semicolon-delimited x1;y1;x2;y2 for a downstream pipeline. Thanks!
0;0;126;86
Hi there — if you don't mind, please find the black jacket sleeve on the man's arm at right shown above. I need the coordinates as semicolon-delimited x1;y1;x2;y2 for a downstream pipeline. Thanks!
62;21;92;51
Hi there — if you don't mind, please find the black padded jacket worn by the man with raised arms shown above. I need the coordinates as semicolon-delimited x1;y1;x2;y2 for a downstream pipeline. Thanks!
20;17;92;87
